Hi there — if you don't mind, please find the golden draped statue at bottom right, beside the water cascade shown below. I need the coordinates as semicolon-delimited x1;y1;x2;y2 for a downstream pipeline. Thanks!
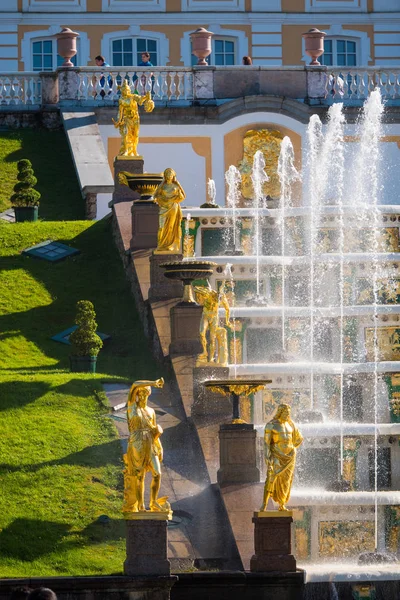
260;404;303;512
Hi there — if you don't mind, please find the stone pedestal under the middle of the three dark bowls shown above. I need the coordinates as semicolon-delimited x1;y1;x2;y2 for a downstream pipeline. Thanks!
169;304;203;355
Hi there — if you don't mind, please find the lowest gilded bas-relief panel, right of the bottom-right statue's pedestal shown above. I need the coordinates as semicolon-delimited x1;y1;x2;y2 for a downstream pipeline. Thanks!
319;521;375;558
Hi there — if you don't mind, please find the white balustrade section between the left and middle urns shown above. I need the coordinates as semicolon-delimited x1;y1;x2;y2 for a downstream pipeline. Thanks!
77;67;193;105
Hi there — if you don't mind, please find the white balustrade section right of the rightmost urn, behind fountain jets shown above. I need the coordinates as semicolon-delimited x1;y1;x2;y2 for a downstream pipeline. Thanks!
326;67;400;103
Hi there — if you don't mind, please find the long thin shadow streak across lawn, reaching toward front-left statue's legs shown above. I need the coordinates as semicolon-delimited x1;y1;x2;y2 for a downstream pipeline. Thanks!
0;439;122;473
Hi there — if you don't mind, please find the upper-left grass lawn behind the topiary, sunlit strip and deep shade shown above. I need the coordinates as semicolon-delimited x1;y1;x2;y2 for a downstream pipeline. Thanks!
0;129;85;221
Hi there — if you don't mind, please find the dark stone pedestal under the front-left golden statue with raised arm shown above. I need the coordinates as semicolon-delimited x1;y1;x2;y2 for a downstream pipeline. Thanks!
124;513;171;577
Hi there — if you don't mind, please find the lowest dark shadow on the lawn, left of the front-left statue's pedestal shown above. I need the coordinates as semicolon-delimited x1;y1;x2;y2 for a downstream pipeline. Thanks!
0;518;125;562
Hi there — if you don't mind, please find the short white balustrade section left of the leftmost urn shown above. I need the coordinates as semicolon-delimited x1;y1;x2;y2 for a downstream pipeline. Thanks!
0;71;42;110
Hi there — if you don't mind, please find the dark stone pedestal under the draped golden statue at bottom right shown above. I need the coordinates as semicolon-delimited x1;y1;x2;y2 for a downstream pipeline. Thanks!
250;510;296;573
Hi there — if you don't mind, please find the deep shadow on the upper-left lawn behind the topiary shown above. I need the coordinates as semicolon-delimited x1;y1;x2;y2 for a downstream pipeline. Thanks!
1;129;85;221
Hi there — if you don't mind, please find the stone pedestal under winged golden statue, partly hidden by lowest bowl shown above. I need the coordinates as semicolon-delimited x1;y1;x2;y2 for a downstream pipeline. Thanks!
192;366;232;418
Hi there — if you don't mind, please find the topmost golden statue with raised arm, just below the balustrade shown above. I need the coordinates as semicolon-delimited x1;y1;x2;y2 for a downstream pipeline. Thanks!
112;79;154;156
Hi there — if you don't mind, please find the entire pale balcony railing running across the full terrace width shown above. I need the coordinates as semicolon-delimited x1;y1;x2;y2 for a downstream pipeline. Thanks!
0;66;400;110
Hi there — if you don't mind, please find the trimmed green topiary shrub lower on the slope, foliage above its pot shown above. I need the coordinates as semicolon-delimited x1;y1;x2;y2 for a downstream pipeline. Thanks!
69;300;103;356
